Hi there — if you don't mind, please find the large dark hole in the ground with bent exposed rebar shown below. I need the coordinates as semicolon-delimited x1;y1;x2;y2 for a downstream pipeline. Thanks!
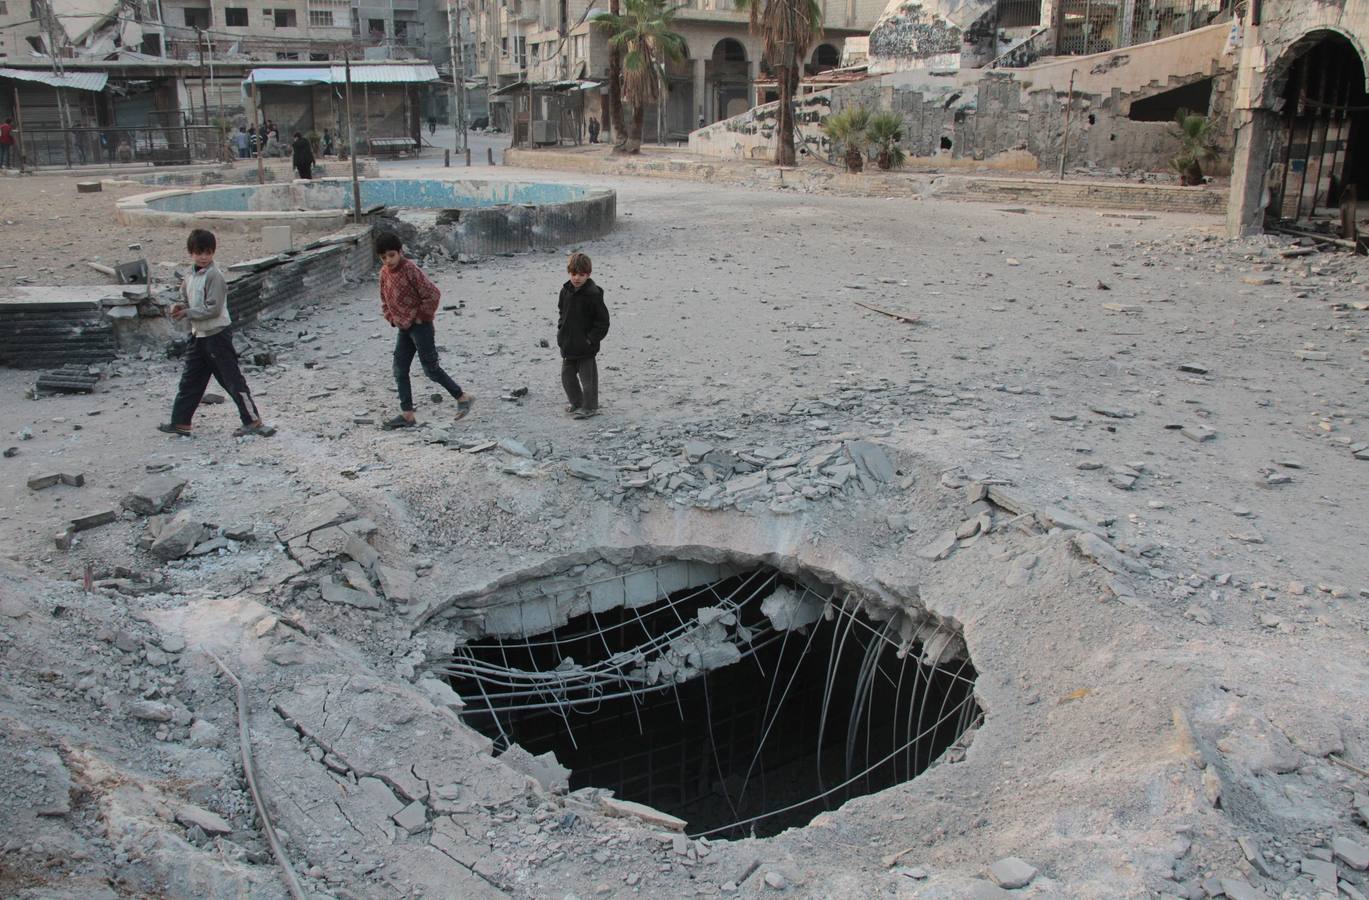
446;560;980;838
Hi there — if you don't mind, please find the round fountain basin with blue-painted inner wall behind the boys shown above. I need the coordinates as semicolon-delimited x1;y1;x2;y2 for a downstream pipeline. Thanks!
115;178;617;255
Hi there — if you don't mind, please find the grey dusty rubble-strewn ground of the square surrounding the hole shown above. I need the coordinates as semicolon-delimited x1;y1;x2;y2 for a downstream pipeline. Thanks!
0;156;1369;897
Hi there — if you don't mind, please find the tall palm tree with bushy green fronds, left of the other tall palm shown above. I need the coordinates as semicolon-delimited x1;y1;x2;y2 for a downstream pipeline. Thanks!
594;0;685;153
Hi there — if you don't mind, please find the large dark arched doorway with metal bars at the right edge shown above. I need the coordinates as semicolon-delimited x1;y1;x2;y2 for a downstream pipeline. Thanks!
1265;32;1369;230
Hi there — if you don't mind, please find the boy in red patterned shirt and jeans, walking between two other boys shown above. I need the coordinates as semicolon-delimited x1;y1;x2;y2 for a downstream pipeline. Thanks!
375;232;475;429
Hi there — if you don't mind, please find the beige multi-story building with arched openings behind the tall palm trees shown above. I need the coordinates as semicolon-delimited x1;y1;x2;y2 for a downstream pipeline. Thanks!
472;0;884;136
